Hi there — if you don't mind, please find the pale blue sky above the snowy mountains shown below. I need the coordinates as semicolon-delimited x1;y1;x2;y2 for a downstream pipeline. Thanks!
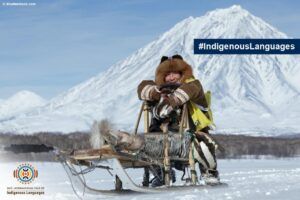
0;0;300;100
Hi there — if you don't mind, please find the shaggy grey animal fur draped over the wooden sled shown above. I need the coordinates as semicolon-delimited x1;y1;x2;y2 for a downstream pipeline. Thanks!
91;120;217;158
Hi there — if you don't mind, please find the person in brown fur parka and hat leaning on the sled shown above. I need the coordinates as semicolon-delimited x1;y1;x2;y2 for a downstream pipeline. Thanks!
138;55;218;186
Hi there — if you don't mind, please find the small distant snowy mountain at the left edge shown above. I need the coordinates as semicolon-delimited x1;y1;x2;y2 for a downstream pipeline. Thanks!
0;90;46;123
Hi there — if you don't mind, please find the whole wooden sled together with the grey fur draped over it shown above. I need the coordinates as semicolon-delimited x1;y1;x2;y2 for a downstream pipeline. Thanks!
56;102;226;194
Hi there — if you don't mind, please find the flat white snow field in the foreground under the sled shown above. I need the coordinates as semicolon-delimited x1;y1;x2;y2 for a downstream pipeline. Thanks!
0;158;300;200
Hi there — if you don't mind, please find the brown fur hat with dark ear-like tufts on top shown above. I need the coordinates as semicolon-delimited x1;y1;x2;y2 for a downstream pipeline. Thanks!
155;55;193;85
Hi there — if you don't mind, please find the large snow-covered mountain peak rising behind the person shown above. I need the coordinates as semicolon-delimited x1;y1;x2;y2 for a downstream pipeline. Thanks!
0;5;300;136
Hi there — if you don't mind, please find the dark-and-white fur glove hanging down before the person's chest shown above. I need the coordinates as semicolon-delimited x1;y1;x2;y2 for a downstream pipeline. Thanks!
152;97;173;120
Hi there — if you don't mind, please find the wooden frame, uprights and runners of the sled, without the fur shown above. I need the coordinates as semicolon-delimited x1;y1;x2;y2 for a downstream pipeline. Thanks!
56;102;226;194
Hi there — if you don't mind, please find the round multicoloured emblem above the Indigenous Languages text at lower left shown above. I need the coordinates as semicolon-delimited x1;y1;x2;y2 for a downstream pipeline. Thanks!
13;163;38;184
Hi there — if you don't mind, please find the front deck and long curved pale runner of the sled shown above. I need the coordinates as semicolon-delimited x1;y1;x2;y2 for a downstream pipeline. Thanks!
57;147;227;195
